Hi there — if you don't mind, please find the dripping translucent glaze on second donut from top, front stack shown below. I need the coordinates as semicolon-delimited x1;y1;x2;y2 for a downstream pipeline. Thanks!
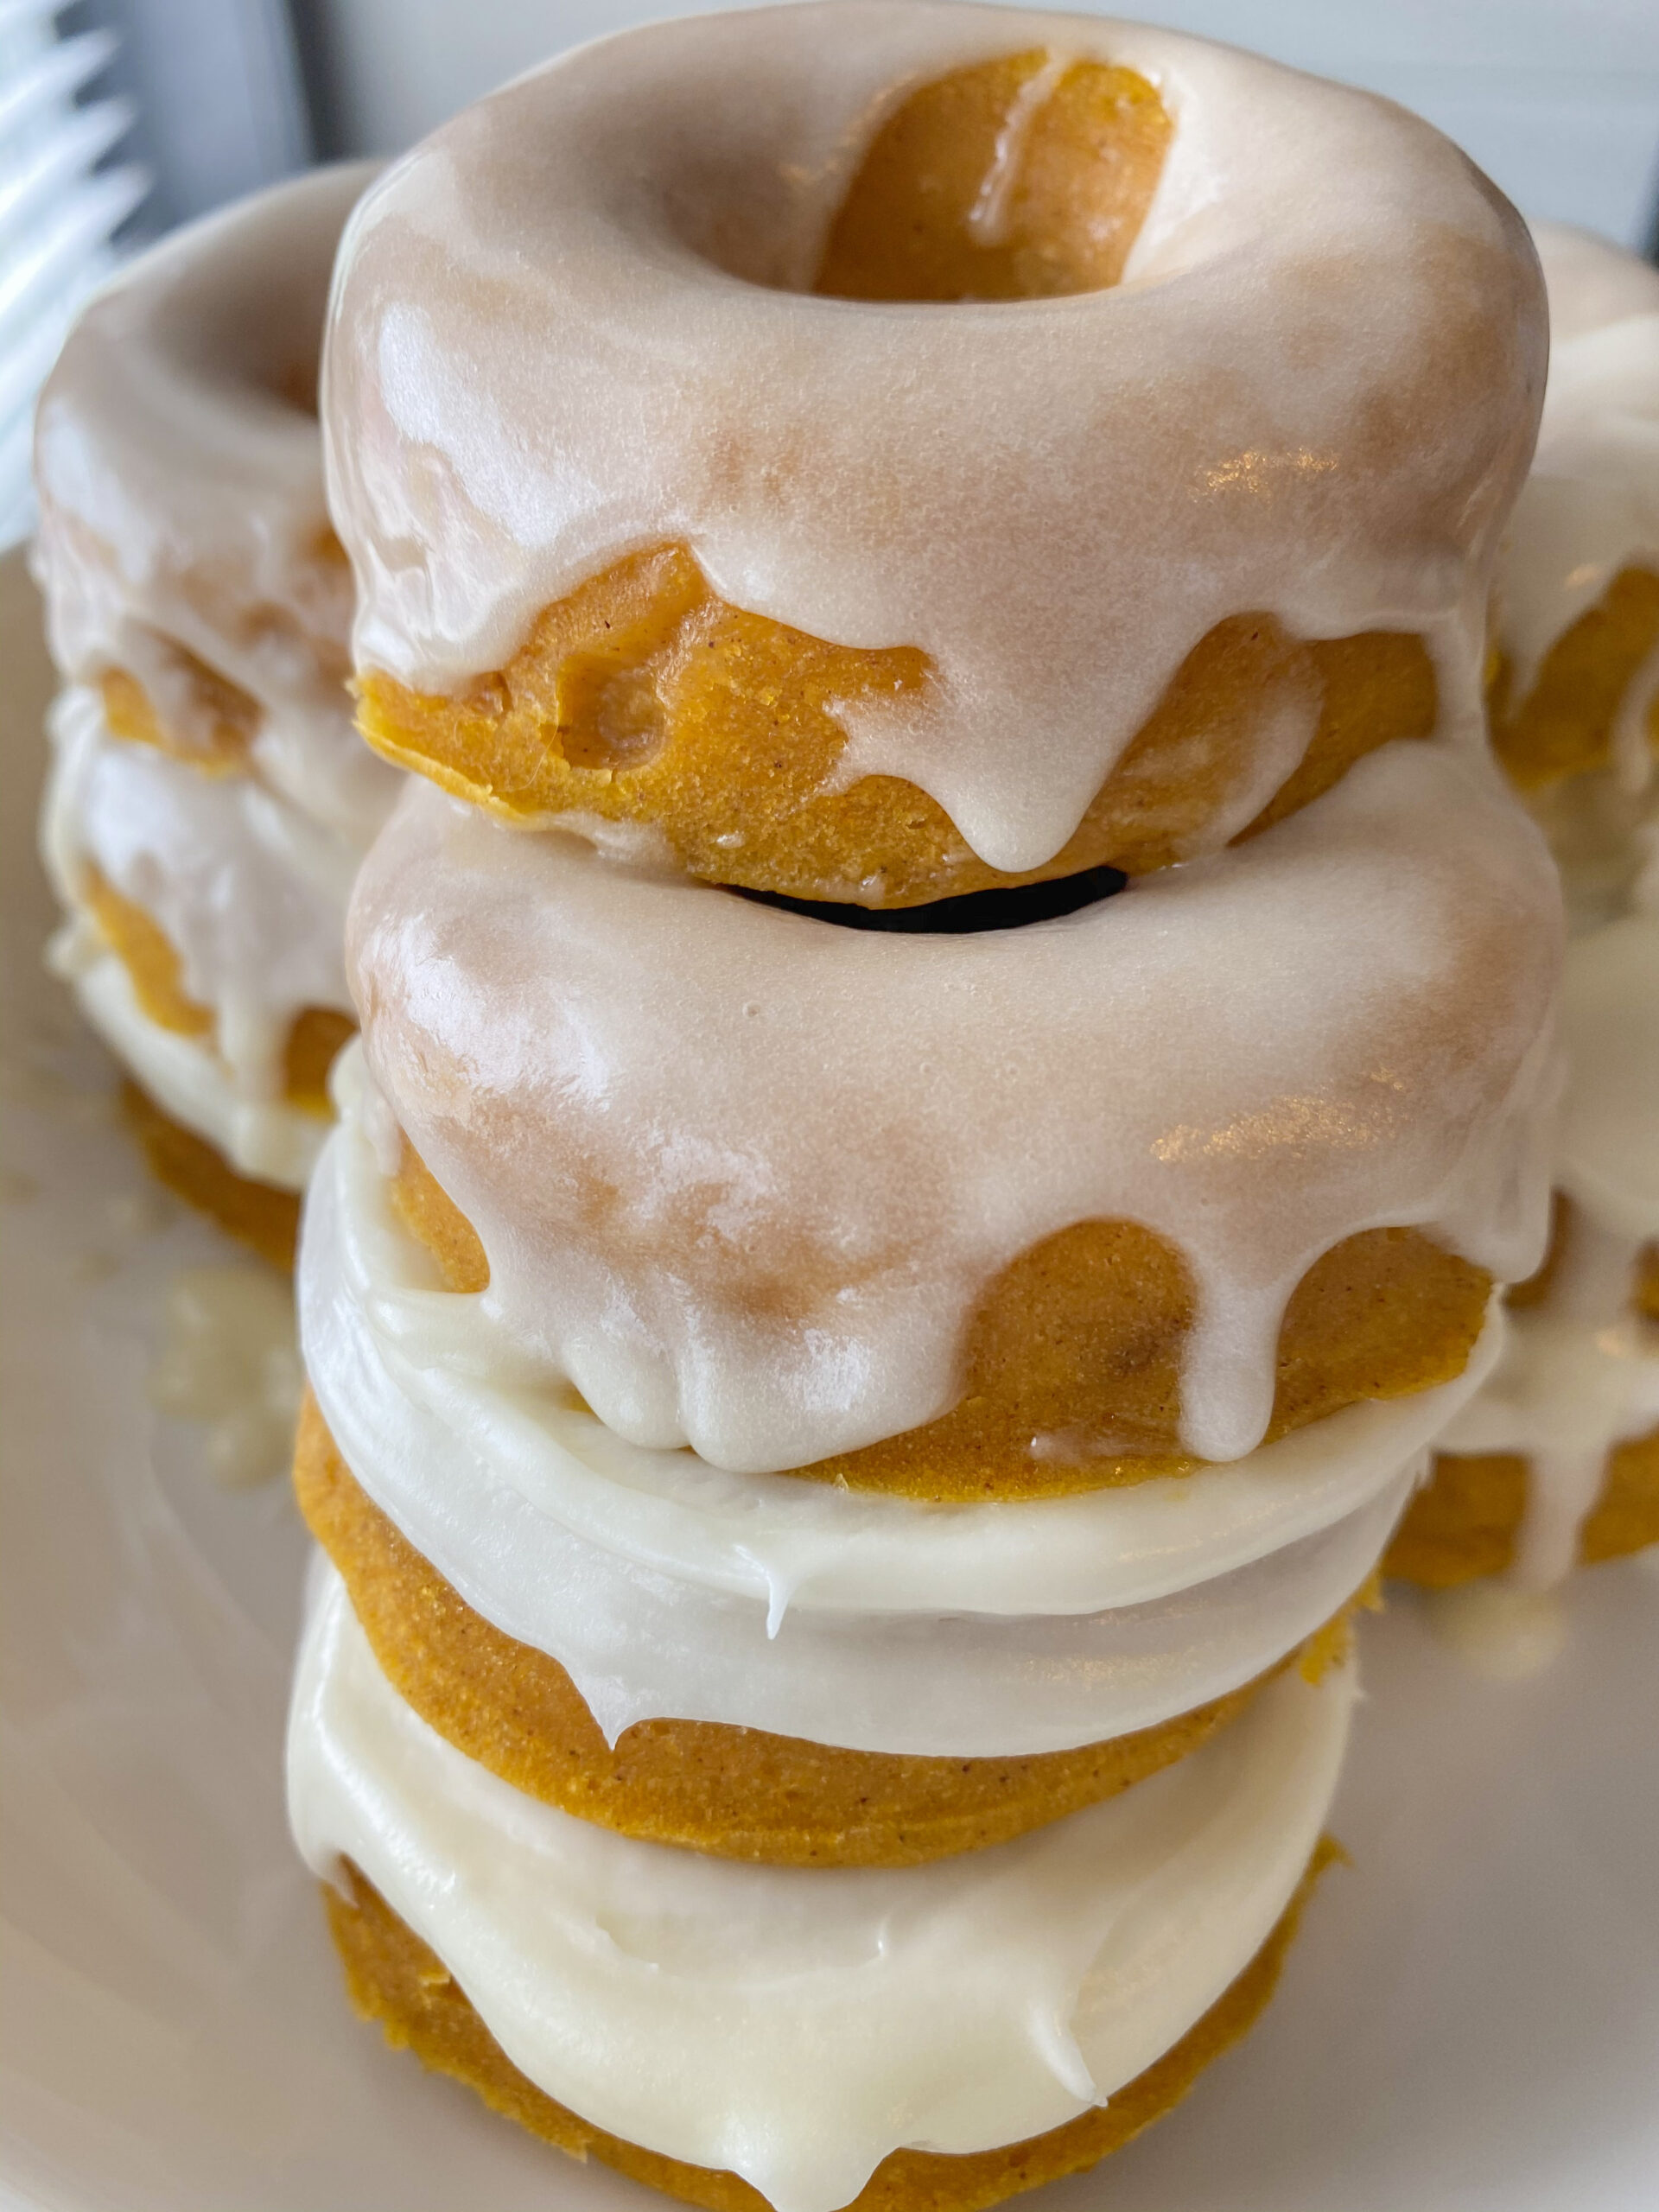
347;743;1560;1471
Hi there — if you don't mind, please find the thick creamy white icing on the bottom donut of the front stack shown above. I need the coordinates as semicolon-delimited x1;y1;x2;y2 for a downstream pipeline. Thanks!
288;1571;1354;2212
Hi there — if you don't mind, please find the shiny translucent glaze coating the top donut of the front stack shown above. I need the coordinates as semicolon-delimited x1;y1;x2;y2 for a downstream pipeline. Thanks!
323;0;1544;869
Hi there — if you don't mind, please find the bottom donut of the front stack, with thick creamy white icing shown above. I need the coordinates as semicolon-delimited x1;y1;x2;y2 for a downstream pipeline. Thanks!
289;1548;1344;2205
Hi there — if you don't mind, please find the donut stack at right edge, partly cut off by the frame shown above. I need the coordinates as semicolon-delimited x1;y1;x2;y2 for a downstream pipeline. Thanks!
1389;226;1659;1588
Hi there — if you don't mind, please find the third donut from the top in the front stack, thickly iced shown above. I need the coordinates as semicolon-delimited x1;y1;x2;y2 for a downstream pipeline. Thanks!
296;1062;1451;1865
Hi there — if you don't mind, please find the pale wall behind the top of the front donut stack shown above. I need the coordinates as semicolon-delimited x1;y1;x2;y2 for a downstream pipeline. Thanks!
292;0;1659;245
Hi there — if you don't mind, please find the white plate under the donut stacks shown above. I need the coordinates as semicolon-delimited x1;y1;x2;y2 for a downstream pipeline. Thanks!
0;539;1659;2212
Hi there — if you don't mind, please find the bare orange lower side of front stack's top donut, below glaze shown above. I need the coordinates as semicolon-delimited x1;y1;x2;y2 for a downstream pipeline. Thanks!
359;546;1435;907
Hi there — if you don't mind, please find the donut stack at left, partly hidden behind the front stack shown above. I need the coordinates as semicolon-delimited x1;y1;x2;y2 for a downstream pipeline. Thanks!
35;166;398;1265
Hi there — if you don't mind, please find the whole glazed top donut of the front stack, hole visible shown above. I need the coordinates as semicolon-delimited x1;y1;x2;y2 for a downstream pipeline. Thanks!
325;0;1544;907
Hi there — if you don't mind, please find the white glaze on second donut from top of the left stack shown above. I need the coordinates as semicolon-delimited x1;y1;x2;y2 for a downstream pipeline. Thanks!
42;686;360;1103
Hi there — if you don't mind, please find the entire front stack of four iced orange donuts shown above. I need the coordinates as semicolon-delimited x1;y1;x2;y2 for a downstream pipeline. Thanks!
289;4;1560;2212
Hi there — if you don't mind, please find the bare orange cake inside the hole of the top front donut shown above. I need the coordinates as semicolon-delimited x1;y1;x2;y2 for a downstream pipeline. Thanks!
812;48;1173;303
